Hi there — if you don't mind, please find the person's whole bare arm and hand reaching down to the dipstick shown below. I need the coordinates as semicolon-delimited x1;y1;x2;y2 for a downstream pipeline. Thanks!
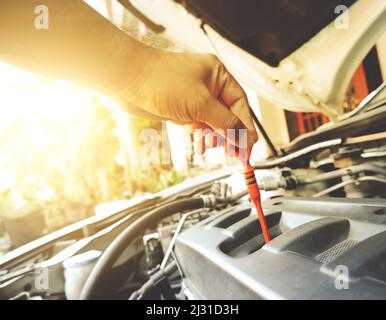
0;0;257;146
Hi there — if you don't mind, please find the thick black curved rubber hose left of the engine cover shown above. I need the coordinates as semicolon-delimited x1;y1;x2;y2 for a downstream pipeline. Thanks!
80;198;204;300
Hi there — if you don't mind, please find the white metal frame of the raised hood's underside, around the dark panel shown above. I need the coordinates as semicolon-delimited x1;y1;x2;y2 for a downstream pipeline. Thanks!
131;0;386;119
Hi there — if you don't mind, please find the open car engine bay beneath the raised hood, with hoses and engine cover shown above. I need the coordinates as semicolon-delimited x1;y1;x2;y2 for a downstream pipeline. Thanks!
0;86;386;300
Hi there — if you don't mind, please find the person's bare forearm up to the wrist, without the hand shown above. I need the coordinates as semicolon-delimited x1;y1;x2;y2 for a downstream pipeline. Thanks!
0;0;154;93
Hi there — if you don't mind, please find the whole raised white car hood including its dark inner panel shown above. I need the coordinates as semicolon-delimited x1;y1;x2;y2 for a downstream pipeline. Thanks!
120;0;386;119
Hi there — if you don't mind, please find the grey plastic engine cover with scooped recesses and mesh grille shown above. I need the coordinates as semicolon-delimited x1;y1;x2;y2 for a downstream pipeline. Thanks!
175;198;386;299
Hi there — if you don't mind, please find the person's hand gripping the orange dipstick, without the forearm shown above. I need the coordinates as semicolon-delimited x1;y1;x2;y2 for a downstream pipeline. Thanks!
122;48;257;153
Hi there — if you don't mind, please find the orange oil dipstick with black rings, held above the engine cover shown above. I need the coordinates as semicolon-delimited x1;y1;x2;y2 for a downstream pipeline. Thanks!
240;148;271;243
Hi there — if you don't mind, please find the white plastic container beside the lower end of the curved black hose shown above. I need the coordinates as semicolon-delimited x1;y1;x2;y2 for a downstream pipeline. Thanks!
63;250;102;300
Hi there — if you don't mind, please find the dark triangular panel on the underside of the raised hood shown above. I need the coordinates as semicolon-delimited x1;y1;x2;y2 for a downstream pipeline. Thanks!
175;0;355;66
